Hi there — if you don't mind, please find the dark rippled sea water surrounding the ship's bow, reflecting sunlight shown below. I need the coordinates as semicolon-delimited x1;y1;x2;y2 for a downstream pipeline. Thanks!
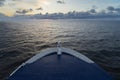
0;19;120;80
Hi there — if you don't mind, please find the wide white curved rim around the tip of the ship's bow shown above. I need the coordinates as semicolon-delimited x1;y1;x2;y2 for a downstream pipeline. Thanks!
26;48;94;64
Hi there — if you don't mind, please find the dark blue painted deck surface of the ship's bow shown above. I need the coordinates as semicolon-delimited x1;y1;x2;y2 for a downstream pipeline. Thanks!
8;53;112;80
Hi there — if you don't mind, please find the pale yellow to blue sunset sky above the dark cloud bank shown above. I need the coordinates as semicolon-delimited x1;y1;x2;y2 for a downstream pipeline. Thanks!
0;0;120;16
